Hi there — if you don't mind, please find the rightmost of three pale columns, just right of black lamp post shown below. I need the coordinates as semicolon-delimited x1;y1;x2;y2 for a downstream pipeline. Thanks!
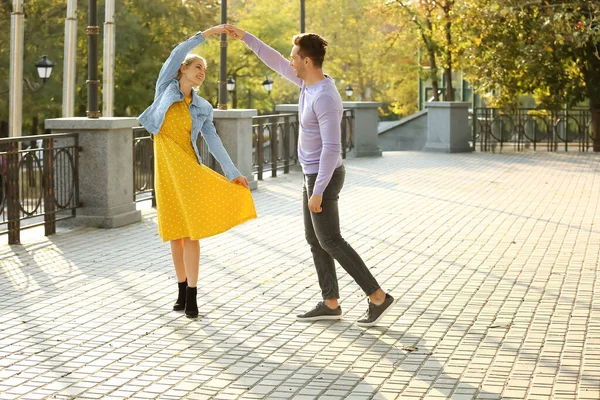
102;0;115;117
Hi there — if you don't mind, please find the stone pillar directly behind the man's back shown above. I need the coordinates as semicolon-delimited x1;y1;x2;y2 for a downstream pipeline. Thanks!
343;101;381;157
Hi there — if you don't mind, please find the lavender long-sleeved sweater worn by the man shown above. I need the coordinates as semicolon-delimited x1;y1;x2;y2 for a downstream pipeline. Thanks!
242;32;344;195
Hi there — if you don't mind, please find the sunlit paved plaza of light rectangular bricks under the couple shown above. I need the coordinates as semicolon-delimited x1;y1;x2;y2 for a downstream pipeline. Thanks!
0;152;600;400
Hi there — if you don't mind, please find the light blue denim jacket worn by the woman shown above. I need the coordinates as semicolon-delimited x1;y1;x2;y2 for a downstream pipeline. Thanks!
138;32;241;180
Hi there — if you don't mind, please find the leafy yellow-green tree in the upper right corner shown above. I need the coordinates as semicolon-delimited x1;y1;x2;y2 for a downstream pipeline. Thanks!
460;0;600;151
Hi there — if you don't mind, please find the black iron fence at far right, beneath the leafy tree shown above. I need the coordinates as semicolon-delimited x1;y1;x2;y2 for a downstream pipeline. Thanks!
471;108;594;152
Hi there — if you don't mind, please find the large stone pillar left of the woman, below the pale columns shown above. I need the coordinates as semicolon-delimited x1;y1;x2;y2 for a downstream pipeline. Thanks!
46;117;142;228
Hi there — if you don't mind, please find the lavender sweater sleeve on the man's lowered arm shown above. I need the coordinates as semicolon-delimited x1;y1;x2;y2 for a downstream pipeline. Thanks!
313;96;342;196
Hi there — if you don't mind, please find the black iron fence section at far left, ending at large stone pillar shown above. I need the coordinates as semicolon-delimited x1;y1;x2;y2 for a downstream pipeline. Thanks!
0;133;80;244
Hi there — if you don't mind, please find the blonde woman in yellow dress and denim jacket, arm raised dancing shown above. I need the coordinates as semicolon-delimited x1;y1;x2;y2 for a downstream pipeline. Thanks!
138;26;256;318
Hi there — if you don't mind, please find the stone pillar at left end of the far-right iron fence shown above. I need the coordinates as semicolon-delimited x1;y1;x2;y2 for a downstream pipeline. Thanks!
423;101;473;153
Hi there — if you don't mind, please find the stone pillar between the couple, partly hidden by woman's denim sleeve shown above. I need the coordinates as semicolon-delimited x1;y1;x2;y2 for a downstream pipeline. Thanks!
213;109;258;190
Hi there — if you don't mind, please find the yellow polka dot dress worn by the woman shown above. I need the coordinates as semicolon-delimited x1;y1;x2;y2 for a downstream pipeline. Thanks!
154;99;256;242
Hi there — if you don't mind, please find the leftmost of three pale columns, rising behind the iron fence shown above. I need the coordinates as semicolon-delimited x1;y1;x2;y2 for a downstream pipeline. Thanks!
8;0;25;137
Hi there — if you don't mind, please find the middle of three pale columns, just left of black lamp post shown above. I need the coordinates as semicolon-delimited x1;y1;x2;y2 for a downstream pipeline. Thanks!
62;0;77;118
